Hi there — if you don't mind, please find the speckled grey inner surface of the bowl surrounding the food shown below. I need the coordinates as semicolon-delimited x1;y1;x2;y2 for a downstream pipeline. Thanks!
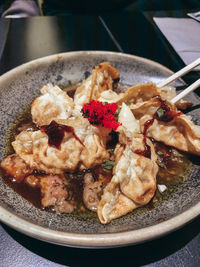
0;52;200;246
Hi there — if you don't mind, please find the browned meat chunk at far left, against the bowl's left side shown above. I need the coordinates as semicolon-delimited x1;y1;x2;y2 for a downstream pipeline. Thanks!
1;154;33;182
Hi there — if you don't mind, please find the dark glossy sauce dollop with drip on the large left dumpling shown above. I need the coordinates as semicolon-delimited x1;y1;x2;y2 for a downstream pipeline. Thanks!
40;121;84;149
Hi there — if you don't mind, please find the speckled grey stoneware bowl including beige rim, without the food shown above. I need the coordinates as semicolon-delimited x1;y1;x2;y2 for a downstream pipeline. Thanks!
0;51;200;248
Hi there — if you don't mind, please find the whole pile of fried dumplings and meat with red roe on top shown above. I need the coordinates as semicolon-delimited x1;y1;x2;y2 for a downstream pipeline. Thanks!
1;62;200;224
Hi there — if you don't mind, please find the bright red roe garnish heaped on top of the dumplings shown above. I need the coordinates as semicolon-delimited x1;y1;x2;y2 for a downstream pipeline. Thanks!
81;100;121;131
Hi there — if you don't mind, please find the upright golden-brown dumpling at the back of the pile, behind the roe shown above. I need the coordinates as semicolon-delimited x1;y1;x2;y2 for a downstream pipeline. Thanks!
74;62;119;110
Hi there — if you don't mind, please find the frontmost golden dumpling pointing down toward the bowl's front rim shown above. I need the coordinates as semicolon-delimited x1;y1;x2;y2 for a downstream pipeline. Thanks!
98;132;158;224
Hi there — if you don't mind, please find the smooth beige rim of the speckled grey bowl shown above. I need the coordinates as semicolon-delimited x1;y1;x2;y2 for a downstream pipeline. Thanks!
0;51;200;248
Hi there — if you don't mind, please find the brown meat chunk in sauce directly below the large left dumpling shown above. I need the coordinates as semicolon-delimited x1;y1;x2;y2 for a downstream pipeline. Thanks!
39;174;74;213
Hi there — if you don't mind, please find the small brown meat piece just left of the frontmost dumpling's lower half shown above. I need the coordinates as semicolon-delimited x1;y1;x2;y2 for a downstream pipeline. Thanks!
83;173;103;214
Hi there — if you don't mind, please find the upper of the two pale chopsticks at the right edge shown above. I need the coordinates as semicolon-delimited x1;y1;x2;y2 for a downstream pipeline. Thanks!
157;58;200;90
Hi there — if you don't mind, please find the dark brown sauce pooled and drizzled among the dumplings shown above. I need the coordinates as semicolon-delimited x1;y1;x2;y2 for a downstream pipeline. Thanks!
0;88;191;217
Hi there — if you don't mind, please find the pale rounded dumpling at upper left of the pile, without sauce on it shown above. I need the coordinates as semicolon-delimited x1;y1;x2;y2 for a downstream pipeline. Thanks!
31;84;74;126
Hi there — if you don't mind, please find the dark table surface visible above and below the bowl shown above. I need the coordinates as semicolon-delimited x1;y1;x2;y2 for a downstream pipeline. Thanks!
0;3;200;267
